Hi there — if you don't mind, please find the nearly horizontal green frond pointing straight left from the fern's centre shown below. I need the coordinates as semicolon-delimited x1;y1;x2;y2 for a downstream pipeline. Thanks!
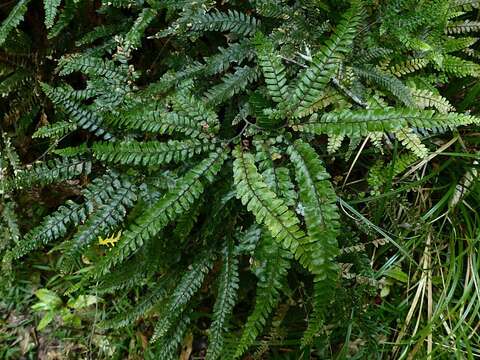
92;140;216;166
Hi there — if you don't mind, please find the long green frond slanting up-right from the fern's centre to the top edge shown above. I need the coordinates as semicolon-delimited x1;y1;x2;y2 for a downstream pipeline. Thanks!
292;1;363;117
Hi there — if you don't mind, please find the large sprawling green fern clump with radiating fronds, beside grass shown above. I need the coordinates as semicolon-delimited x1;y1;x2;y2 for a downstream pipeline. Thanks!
0;0;480;360
